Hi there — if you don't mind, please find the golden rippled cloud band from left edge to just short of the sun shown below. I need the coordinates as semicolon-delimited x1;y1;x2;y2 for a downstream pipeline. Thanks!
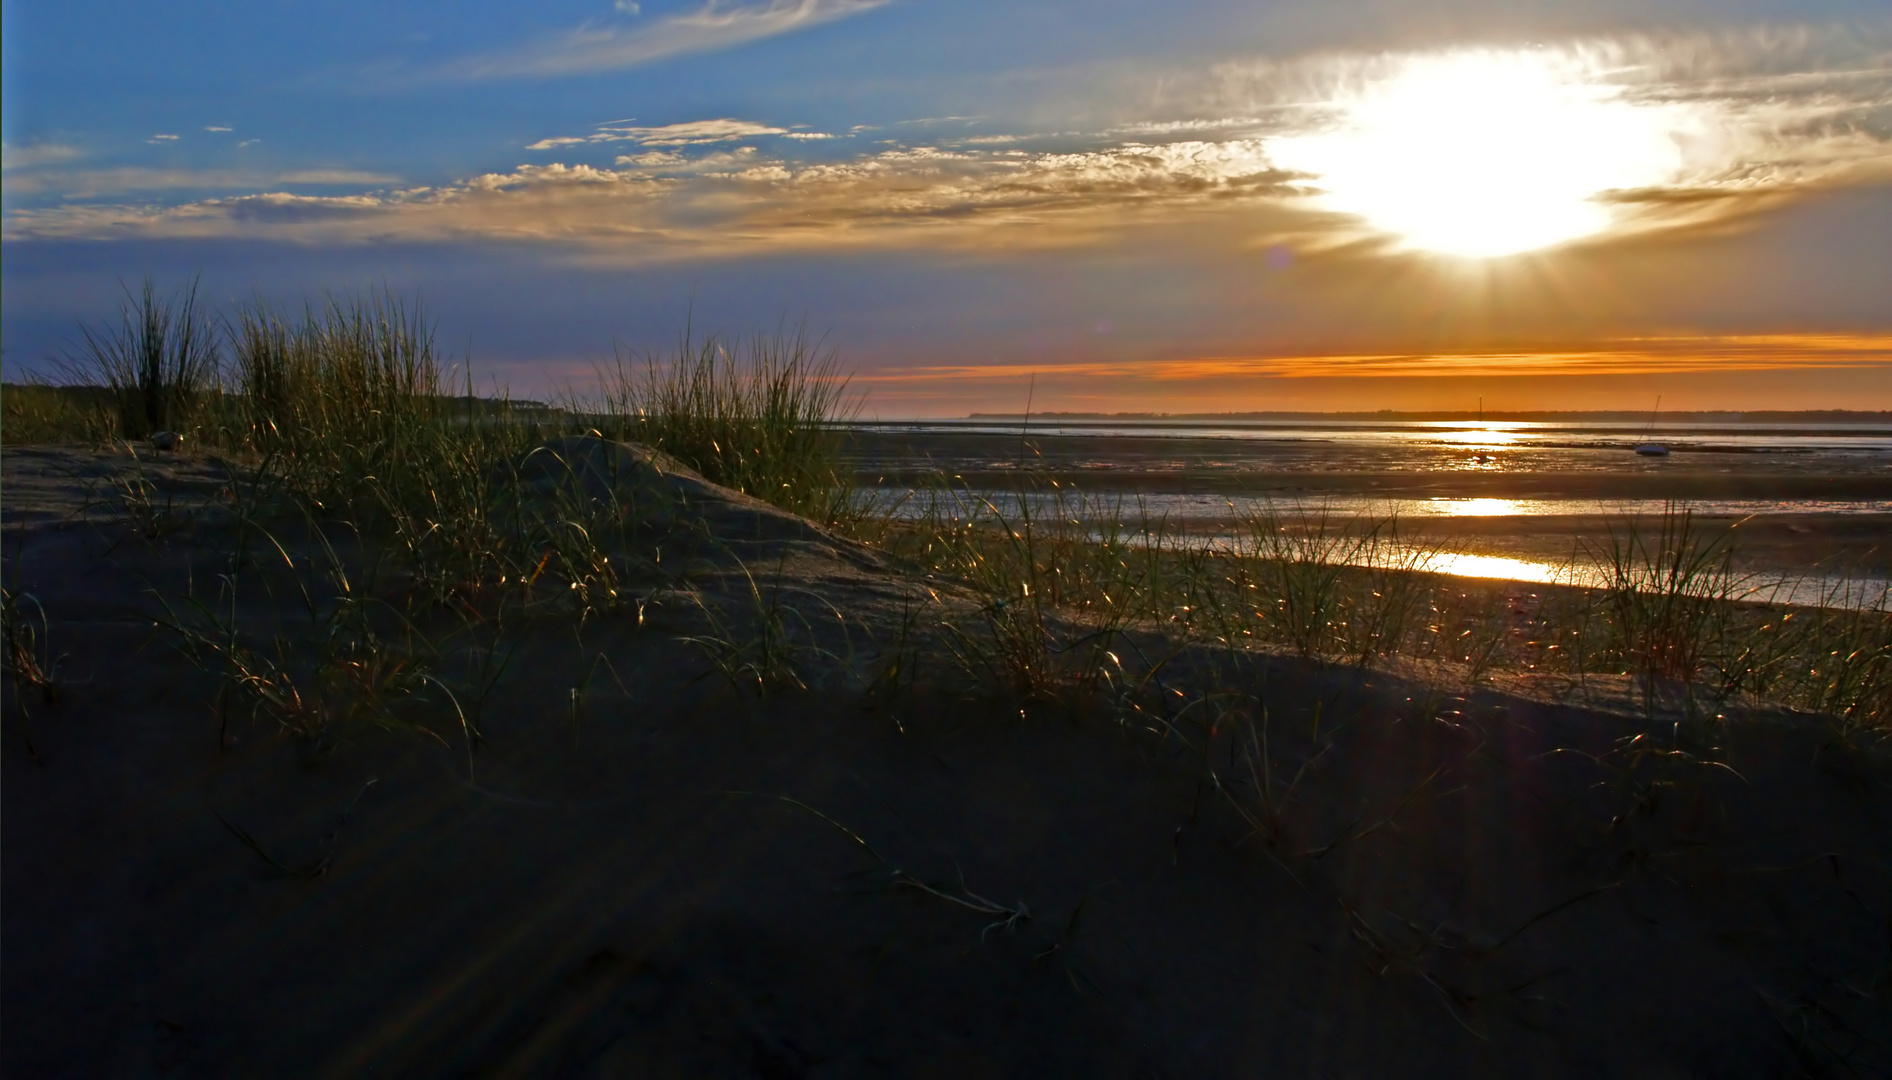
6;142;1288;261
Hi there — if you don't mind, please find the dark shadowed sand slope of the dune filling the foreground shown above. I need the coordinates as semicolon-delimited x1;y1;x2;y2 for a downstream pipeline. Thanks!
0;450;1892;1078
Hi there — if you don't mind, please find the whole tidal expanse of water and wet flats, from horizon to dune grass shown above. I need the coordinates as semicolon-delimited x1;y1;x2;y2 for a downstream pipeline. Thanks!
848;420;1892;607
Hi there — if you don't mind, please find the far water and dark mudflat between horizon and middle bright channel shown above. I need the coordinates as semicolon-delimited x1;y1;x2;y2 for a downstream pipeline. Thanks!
850;422;1892;503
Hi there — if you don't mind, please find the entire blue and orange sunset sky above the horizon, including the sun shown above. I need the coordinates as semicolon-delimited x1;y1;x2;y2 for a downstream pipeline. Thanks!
0;0;1892;418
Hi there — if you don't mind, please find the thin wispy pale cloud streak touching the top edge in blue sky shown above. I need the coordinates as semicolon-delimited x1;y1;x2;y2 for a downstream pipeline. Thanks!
443;0;887;79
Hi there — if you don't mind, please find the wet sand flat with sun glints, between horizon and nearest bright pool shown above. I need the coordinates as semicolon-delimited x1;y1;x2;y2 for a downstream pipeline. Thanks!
850;426;1892;577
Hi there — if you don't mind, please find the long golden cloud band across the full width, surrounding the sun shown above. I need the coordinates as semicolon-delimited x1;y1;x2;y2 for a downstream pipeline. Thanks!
4;32;1892;263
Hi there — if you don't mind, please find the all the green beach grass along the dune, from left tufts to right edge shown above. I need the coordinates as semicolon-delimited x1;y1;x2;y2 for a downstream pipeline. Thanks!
4;284;1892;730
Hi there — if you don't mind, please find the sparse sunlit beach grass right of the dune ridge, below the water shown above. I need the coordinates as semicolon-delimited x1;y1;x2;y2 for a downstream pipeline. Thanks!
874;484;1892;728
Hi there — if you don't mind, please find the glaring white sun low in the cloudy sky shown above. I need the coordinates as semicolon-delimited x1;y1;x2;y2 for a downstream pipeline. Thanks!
1270;49;1684;257
